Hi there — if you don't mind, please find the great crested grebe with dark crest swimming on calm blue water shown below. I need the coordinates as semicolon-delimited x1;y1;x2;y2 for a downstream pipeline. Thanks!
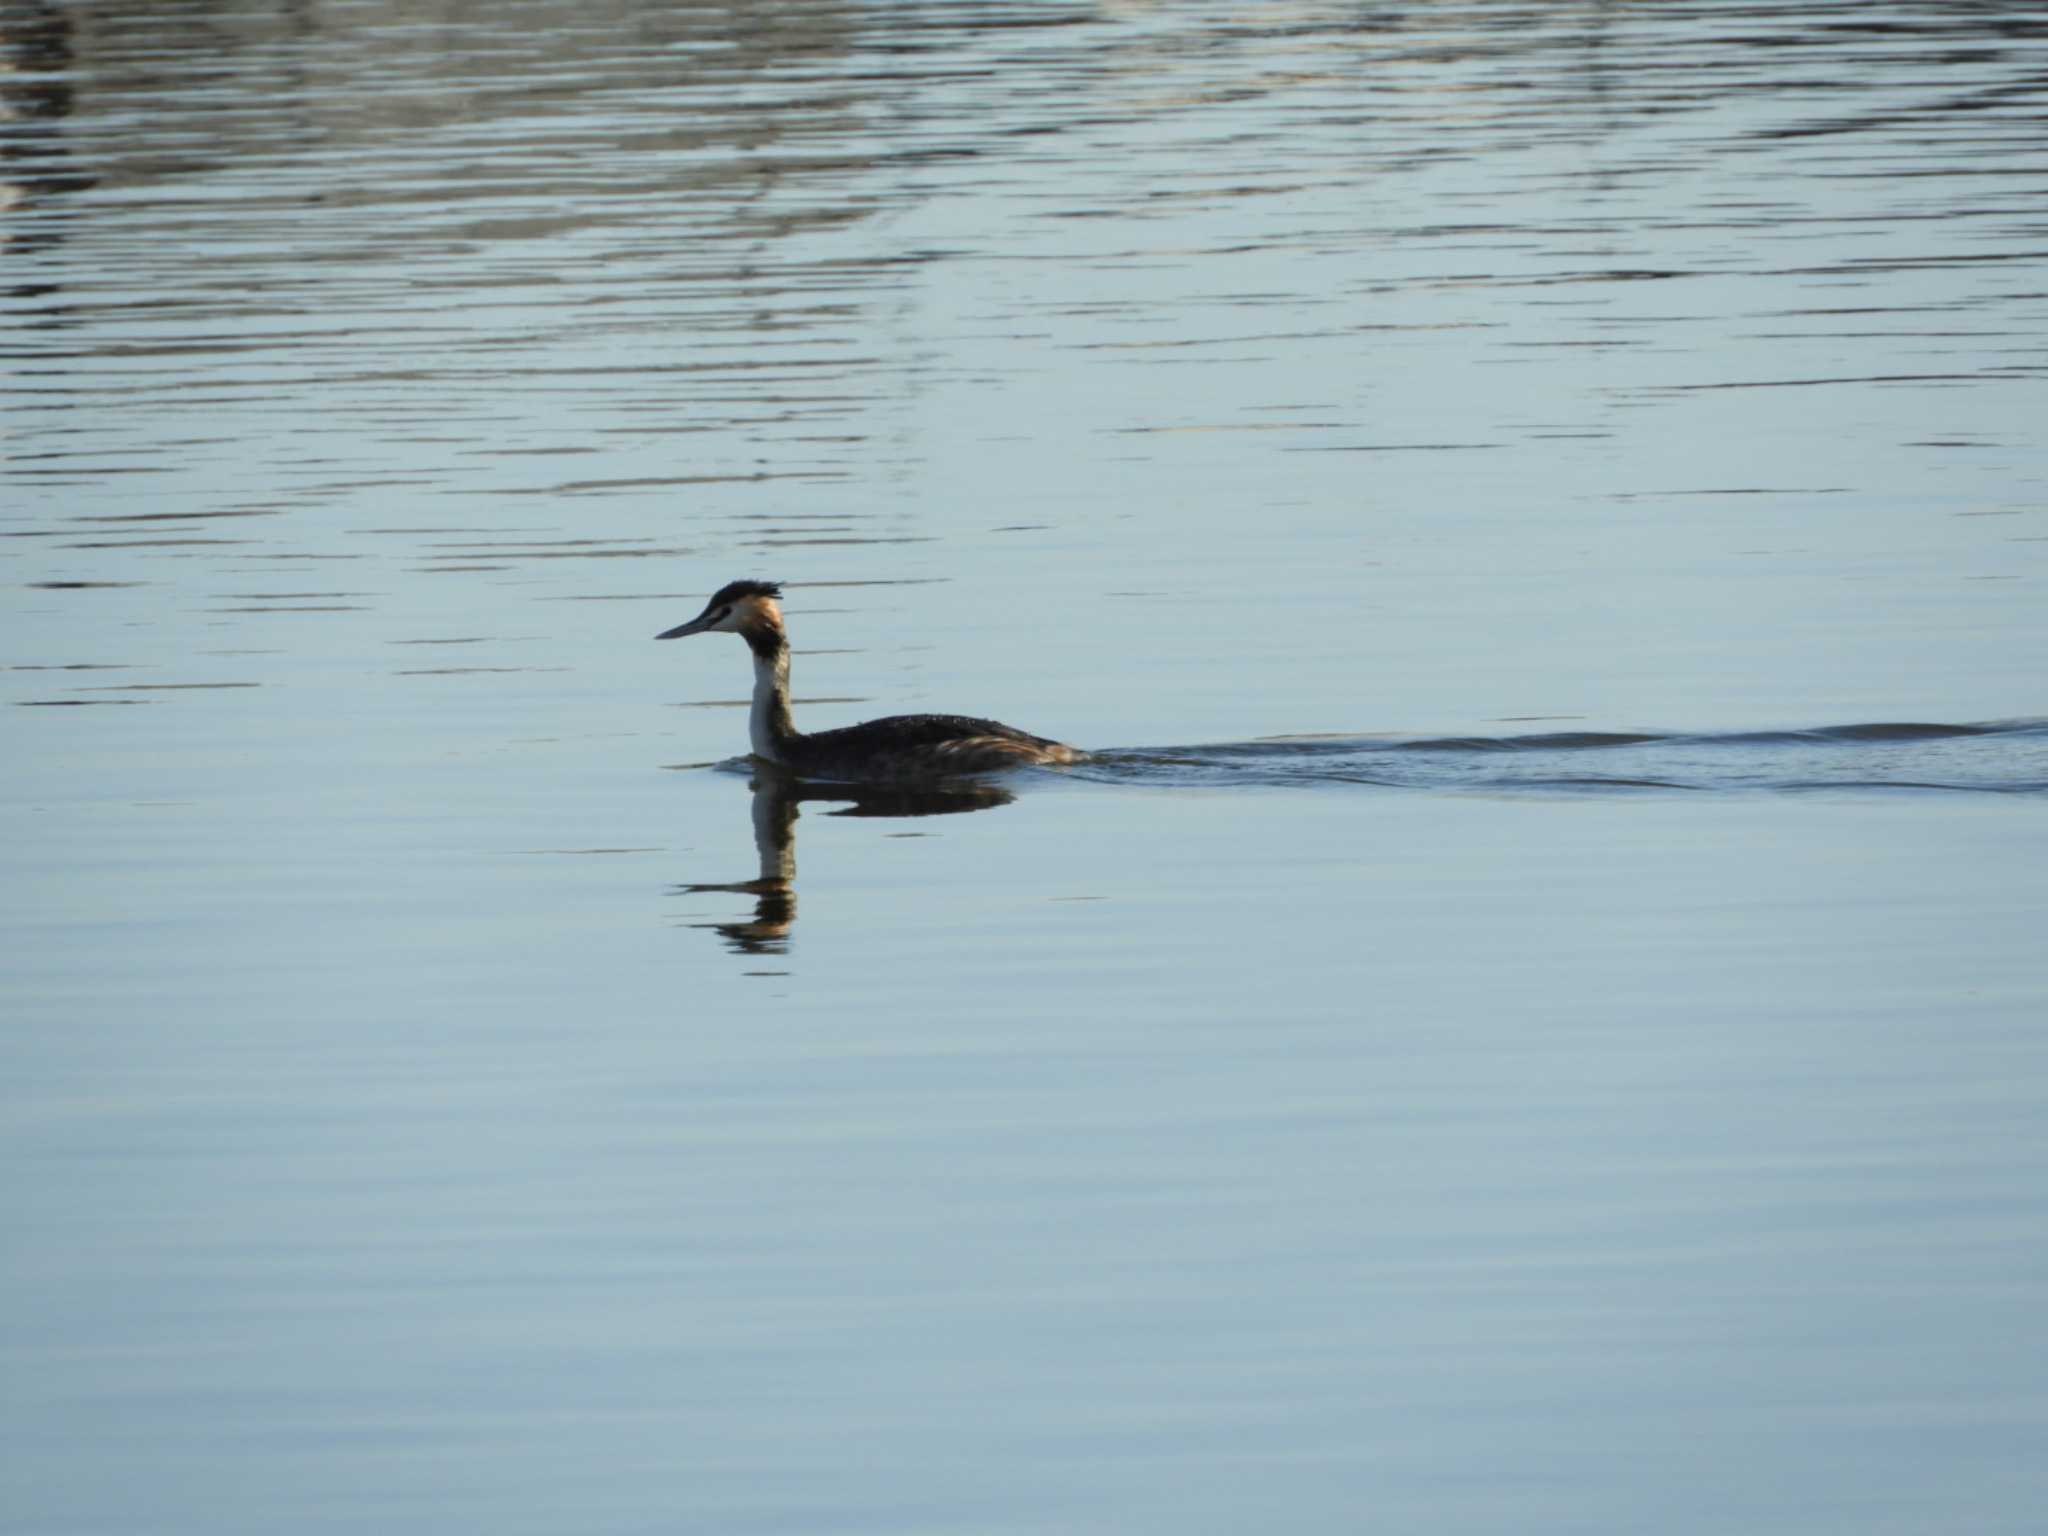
655;582;1085;780
